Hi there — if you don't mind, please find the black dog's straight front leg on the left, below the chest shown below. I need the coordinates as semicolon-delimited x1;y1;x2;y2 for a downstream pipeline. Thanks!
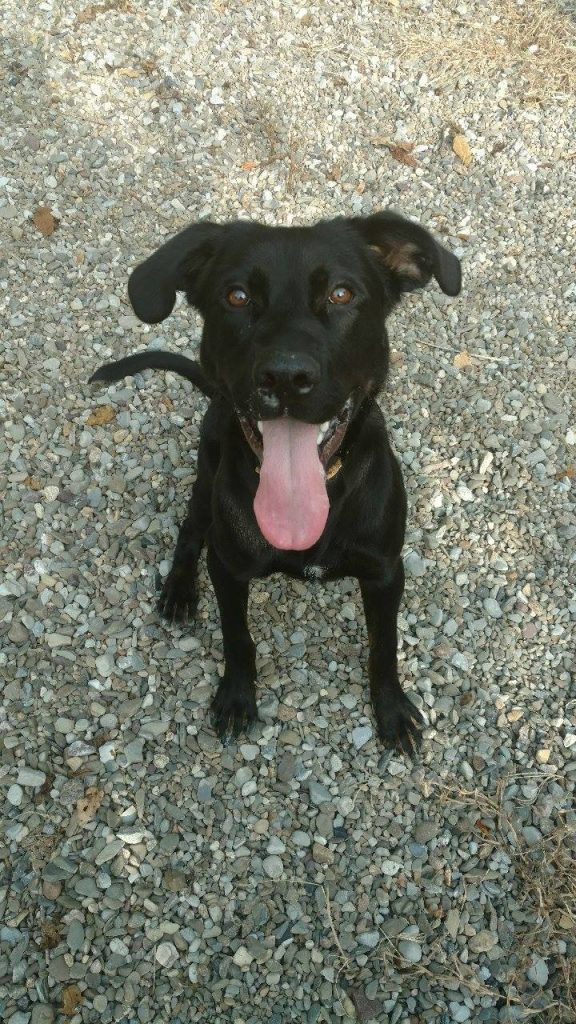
204;545;258;739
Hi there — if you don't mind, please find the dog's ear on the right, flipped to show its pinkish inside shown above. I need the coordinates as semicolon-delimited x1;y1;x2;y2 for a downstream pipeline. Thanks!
352;212;462;295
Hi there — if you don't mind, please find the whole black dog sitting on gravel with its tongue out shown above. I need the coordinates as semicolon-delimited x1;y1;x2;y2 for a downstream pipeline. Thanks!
92;213;460;752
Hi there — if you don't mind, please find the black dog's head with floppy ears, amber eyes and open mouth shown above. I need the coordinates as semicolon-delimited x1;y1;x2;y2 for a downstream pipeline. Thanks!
128;212;460;547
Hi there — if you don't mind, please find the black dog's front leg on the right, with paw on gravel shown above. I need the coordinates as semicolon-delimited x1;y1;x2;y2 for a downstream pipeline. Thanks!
360;558;422;754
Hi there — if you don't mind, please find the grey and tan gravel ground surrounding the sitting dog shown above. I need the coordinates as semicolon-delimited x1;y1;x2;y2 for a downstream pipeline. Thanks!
0;0;576;1024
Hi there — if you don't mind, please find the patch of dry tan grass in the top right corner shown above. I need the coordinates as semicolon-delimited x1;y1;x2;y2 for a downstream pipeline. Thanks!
399;0;576;102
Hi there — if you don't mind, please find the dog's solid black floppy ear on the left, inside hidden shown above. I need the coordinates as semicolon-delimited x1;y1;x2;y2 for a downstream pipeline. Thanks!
128;220;225;324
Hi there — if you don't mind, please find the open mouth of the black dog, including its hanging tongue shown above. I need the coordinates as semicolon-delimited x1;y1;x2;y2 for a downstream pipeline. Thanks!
235;396;354;551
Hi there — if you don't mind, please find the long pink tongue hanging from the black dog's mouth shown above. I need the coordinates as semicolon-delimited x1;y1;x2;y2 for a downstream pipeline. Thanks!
254;417;329;551
